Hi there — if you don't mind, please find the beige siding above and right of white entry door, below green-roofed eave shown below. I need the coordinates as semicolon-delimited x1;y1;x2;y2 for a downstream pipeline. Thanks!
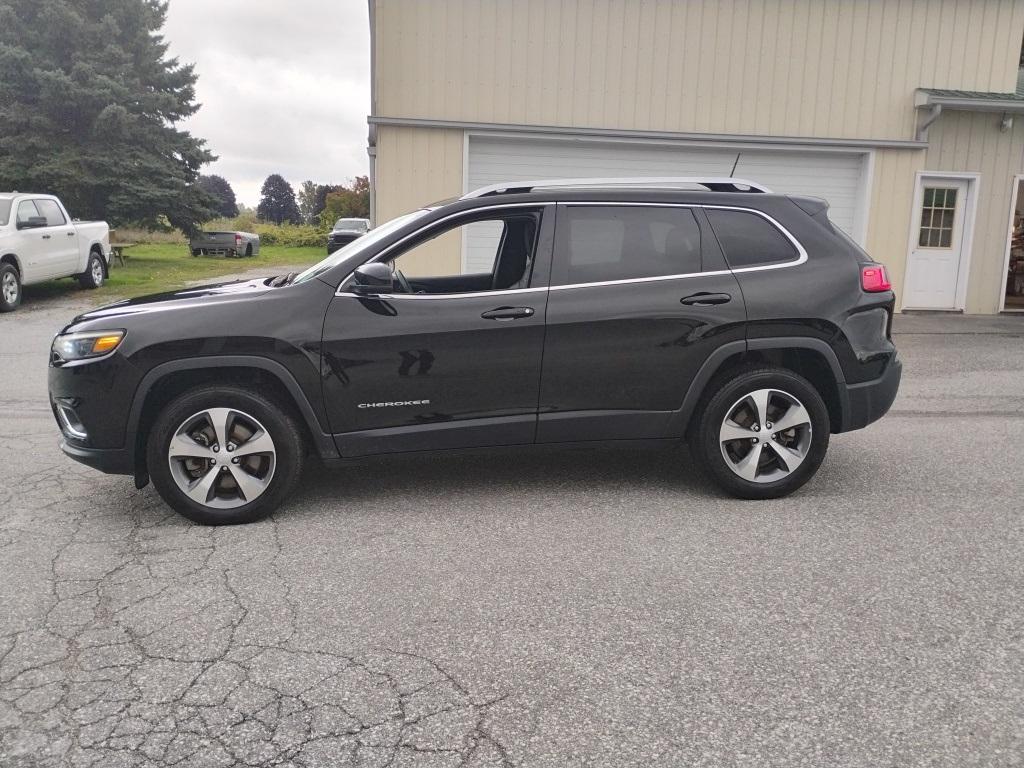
924;112;1024;313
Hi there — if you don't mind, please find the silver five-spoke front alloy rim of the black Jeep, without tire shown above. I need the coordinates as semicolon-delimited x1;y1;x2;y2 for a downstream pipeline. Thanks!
167;408;276;509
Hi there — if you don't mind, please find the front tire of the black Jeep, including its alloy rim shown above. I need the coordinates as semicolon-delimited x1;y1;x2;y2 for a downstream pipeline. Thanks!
146;385;305;525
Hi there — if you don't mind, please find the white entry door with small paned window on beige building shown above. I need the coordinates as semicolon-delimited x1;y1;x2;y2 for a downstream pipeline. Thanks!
903;177;969;309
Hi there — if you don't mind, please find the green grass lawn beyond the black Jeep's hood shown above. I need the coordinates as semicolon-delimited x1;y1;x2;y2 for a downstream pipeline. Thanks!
25;244;327;303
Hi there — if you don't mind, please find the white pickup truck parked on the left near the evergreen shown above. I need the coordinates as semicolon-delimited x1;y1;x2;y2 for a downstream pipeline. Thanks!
0;193;111;312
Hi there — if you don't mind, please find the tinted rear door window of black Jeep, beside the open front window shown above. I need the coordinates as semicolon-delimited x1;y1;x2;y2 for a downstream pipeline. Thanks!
551;205;702;286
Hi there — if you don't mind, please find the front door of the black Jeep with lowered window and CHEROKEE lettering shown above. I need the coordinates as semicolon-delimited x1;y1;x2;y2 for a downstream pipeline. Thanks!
322;206;553;456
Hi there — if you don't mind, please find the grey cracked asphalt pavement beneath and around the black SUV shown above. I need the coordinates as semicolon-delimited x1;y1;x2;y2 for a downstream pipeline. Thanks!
0;294;1024;768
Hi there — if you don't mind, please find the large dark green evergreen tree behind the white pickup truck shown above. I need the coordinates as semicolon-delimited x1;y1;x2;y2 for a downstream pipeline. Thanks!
0;0;214;231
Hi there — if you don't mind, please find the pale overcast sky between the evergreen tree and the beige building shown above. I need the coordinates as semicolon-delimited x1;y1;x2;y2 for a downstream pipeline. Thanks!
164;0;370;206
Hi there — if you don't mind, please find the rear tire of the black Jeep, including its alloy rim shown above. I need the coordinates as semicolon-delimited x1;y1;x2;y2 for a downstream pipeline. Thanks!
690;368;830;499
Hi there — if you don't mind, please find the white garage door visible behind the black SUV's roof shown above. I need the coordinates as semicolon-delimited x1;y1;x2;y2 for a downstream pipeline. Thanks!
466;136;865;271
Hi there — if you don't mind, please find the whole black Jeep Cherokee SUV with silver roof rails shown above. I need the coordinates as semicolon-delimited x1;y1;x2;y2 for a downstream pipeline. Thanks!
49;179;901;523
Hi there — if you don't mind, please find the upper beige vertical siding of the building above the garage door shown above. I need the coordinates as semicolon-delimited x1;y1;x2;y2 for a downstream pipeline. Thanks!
376;0;1024;138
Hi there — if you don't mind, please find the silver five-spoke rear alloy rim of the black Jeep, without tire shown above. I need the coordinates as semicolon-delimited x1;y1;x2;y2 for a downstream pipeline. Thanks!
719;389;811;482
